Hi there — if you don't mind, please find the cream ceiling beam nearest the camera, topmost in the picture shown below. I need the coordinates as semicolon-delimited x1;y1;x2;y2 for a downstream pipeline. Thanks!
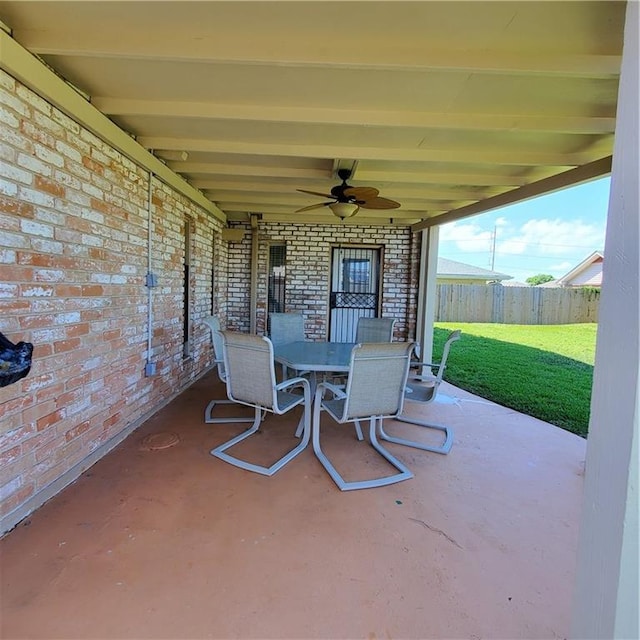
18;28;622;78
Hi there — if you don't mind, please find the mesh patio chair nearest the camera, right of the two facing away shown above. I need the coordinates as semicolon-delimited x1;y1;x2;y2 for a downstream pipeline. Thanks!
312;342;414;491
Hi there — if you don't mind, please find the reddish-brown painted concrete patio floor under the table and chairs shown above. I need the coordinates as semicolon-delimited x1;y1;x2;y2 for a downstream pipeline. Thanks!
0;373;586;640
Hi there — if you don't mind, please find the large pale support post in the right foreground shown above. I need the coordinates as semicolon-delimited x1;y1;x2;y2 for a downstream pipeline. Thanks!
571;2;640;640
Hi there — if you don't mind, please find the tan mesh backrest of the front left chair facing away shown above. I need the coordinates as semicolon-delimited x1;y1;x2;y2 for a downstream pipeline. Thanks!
222;331;277;409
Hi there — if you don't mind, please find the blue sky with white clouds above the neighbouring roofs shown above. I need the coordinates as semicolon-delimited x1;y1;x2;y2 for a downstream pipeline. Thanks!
438;177;611;282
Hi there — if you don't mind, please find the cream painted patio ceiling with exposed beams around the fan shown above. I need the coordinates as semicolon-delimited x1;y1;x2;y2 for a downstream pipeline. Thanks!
0;0;625;229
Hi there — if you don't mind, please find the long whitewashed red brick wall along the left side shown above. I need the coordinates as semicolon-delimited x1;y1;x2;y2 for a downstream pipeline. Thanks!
0;72;228;528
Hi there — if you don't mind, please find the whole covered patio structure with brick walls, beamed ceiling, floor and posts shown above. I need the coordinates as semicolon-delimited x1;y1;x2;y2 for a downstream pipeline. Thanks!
0;1;640;639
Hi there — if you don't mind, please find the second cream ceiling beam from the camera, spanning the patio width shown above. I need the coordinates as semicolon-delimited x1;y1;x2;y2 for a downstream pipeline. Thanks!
91;96;615;134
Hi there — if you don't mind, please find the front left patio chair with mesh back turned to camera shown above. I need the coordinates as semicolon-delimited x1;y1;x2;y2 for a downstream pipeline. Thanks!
211;331;311;476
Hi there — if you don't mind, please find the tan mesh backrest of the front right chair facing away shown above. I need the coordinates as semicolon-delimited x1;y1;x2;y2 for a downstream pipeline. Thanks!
342;342;414;421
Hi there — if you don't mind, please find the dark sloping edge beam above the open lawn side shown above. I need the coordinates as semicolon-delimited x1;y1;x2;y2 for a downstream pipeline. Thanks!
412;156;611;232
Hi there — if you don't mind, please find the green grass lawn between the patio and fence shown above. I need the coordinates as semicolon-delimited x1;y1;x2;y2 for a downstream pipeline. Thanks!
434;322;597;437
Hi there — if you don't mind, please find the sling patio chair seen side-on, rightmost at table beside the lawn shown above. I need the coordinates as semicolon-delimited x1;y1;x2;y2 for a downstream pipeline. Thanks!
379;329;461;455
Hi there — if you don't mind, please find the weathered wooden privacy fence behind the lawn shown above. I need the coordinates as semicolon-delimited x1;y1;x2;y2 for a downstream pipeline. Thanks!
436;284;600;324
